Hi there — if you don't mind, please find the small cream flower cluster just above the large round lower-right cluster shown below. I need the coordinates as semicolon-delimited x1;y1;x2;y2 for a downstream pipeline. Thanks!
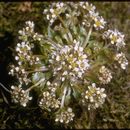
99;66;112;84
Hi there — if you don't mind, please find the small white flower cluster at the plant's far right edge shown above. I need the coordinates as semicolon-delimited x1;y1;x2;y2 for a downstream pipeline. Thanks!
115;52;128;70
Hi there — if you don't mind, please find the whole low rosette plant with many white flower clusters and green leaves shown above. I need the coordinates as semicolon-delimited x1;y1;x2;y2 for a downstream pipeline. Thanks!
9;2;128;128
